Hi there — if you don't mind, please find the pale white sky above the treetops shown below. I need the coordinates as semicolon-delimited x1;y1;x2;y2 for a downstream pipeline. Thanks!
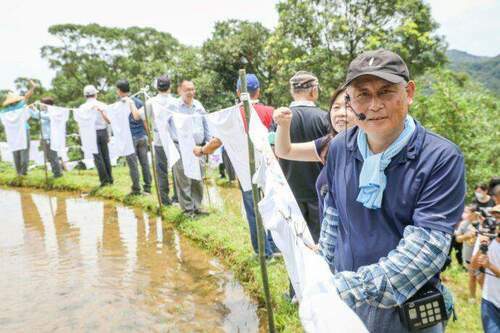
0;0;500;89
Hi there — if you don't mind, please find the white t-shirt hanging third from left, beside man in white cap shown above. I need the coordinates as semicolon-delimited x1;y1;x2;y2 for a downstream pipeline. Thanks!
73;104;98;159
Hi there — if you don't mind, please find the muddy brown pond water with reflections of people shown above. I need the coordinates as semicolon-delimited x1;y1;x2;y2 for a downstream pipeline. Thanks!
0;189;259;332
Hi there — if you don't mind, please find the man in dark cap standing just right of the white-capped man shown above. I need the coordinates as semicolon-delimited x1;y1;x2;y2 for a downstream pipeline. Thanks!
116;80;152;195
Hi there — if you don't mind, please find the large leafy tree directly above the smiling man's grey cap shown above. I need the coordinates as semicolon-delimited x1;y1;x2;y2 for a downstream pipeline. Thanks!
267;0;446;106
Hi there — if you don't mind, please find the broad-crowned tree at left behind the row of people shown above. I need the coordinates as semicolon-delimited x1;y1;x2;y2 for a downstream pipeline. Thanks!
41;24;184;105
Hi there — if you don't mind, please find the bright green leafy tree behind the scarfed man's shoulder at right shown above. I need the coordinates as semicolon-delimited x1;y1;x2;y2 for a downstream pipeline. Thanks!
411;69;500;194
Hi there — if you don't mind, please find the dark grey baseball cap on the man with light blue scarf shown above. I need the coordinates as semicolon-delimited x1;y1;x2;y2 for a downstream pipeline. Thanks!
344;49;410;87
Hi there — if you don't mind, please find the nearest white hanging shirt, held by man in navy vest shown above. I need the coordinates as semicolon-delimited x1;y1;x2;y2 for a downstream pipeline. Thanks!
258;175;367;333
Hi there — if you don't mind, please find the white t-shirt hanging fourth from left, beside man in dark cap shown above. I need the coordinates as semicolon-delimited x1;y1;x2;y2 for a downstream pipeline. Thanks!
106;100;135;156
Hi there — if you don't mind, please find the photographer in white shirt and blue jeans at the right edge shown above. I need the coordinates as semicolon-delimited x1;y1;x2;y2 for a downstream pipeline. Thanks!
471;205;500;333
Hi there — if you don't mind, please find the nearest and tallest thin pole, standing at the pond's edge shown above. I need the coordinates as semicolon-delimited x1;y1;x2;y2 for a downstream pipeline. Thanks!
239;69;276;333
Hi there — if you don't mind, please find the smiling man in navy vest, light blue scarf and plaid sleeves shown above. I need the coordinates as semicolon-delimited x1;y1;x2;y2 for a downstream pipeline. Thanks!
319;50;465;333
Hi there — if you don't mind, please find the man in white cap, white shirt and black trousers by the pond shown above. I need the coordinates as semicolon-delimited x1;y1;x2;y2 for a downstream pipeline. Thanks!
80;85;113;186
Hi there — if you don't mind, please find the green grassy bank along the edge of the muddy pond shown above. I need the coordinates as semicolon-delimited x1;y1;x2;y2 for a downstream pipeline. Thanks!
0;162;481;332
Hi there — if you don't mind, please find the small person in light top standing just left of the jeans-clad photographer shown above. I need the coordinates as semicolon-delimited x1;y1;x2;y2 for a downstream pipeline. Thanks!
455;206;480;304
